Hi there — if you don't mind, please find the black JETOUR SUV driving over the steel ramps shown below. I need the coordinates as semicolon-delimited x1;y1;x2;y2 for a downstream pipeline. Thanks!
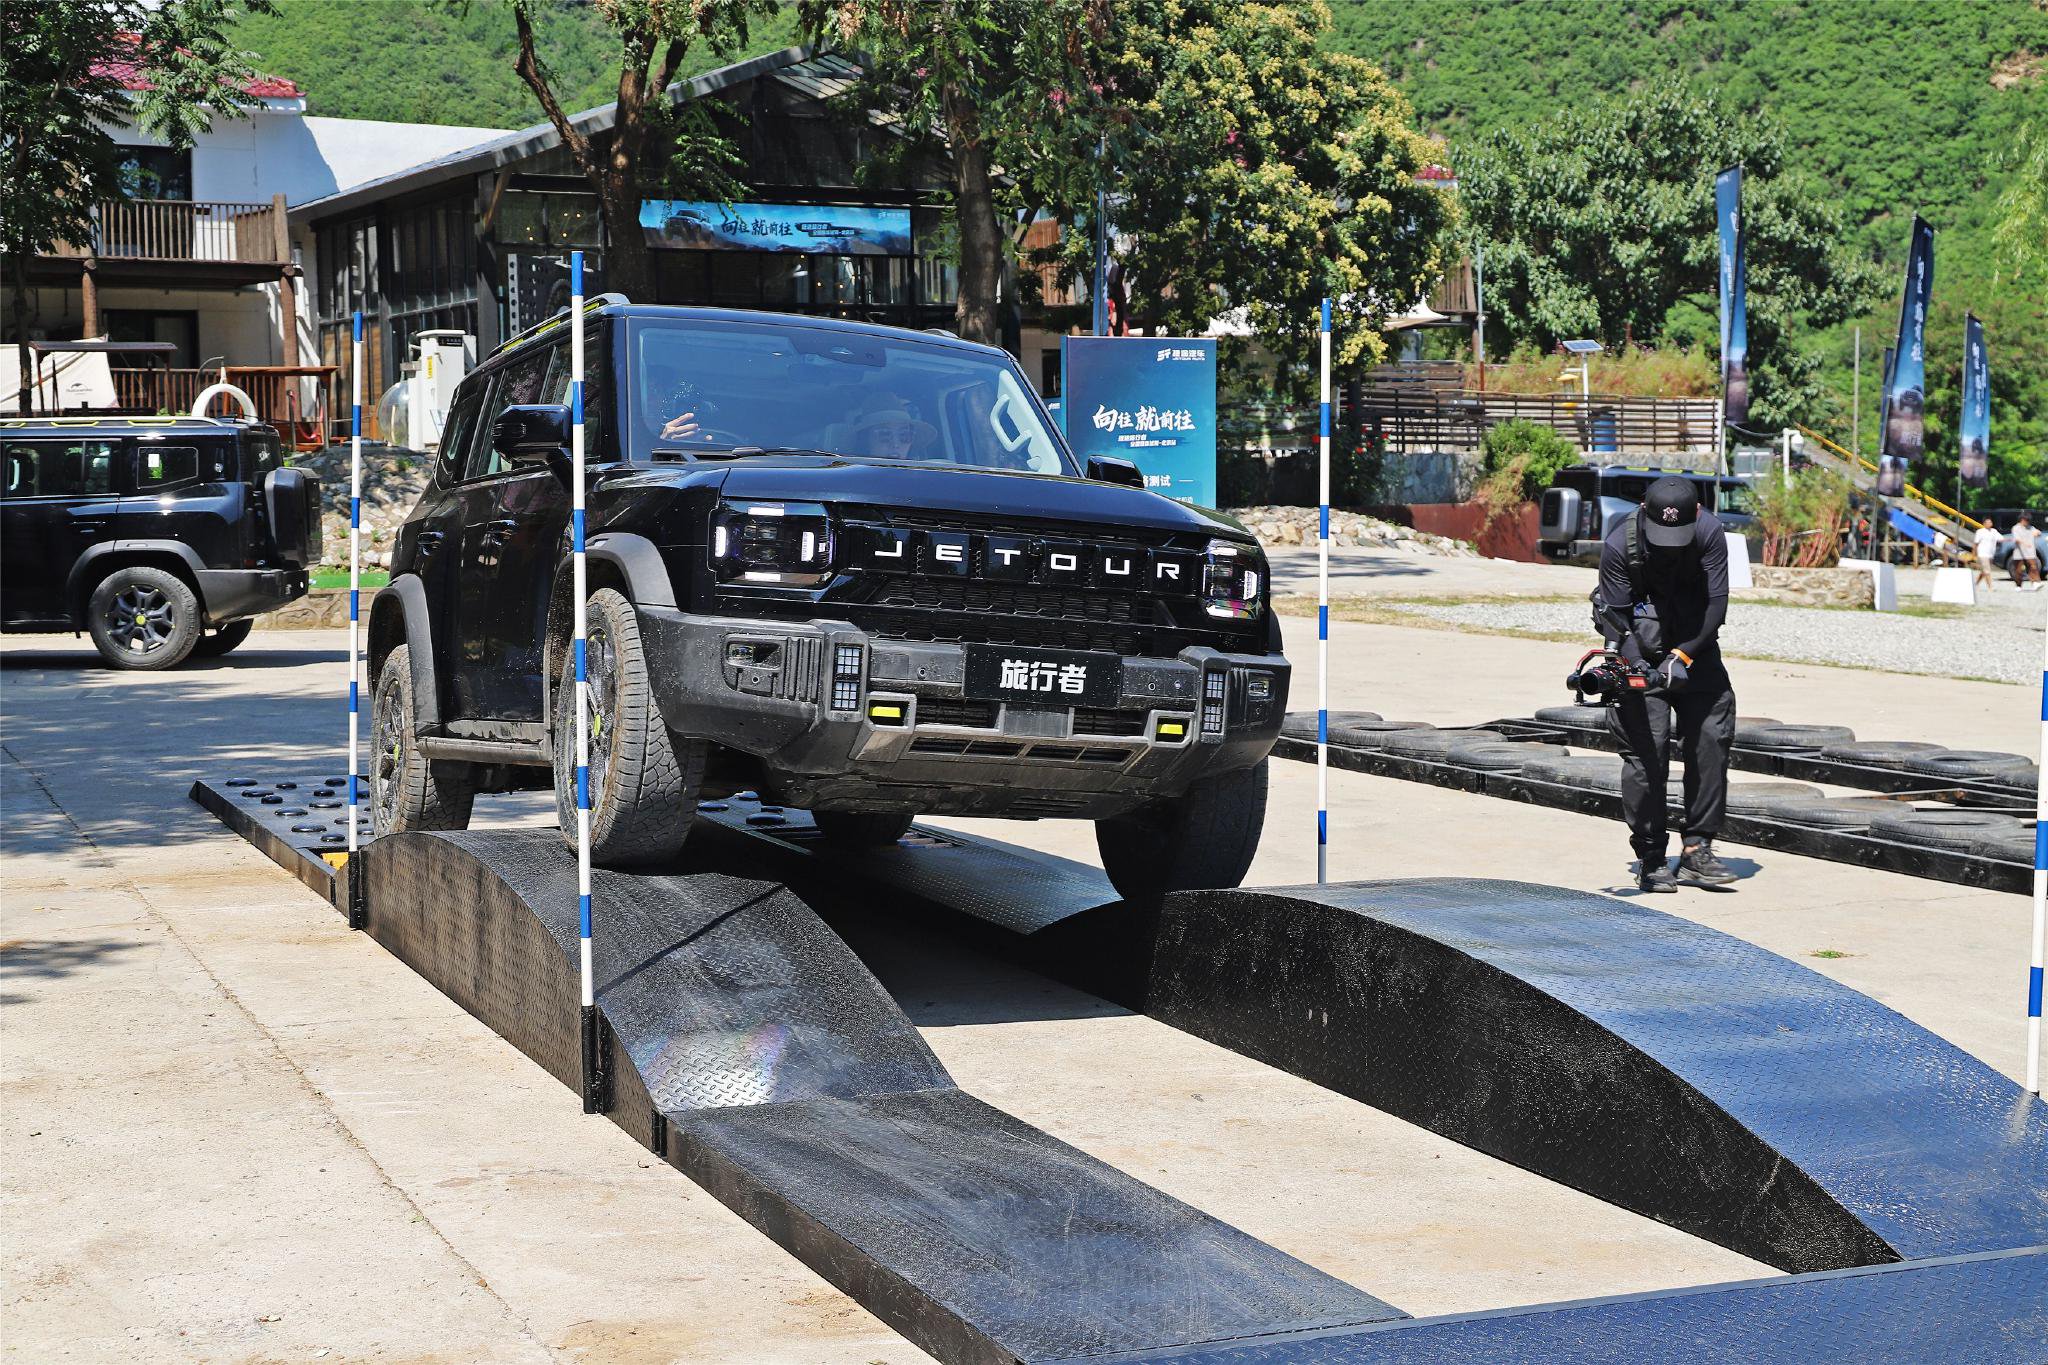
369;297;1288;896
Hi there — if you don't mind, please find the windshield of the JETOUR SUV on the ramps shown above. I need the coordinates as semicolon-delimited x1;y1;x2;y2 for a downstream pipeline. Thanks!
621;317;1075;475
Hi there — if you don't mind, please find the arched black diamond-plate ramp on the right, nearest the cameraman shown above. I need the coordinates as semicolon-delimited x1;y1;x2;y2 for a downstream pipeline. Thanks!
696;821;2048;1271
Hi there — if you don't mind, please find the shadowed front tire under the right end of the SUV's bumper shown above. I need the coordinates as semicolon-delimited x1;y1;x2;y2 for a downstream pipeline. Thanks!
1096;759;1270;902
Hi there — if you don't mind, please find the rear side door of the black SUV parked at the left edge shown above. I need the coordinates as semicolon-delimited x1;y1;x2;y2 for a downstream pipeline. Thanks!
0;436;127;624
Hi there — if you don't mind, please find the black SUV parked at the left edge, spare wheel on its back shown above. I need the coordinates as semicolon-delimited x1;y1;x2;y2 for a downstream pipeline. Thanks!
0;415;319;669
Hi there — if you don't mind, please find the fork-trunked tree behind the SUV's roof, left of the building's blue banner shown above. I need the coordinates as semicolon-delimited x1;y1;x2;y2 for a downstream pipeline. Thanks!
512;0;776;299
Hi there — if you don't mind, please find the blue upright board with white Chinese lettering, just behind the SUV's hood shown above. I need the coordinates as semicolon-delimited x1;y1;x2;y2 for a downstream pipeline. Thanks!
1059;336;1217;508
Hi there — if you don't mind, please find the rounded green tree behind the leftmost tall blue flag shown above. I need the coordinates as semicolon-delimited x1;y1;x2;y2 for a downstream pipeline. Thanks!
1460;84;1876;426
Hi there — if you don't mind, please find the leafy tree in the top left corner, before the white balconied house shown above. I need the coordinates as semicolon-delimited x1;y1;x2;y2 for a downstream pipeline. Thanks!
0;0;266;411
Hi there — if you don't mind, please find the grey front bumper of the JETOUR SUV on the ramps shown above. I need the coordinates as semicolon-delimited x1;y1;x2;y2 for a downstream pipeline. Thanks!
639;606;1288;819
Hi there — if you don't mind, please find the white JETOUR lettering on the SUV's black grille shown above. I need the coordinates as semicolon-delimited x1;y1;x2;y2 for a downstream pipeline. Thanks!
848;526;1202;596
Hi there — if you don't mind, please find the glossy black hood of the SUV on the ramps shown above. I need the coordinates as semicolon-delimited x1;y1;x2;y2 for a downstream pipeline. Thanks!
704;454;1251;540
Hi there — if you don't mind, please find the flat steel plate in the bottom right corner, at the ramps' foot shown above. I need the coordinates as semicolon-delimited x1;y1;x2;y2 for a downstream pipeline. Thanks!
1112;1248;2048;1365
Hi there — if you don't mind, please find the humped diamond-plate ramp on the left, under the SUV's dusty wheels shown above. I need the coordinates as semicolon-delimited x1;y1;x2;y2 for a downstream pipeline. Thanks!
360;831;1403;1361
